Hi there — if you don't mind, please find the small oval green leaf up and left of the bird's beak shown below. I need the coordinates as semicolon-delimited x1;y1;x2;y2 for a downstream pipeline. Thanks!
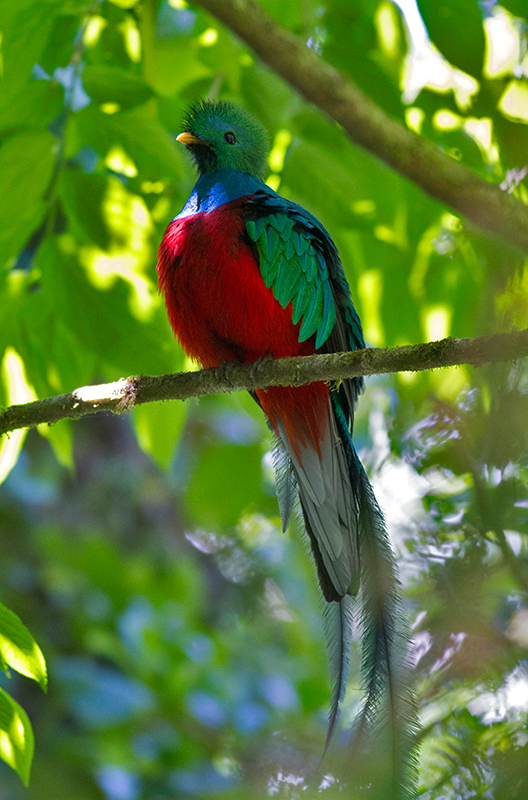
82;64;153;108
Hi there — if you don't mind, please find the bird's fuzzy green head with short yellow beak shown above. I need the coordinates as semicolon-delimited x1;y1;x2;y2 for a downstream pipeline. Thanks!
177;100;269;178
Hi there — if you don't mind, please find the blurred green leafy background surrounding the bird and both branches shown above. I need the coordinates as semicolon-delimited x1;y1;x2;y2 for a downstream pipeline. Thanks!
0;0;528;800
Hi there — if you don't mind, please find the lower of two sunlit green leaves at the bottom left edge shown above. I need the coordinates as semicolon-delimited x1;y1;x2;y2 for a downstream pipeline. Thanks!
0;689;35;786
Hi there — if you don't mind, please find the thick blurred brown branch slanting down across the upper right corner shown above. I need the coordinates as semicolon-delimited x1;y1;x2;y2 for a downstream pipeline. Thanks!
191;0;528;252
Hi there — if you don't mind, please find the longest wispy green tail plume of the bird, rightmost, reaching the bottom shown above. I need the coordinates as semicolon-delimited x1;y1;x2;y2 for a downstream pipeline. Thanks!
351;456;417;800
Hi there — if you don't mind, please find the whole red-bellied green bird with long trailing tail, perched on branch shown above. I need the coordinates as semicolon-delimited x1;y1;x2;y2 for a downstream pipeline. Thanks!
157;99;413;798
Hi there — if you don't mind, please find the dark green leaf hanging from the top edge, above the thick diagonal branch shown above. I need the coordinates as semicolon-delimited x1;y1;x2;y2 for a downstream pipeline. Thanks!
418;0;485;79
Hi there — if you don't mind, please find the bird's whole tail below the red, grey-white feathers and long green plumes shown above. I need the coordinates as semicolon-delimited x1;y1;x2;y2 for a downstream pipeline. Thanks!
274;392;416;800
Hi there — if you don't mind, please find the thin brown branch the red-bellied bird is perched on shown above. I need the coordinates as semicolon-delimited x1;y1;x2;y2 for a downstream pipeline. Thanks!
0;329;528;434
